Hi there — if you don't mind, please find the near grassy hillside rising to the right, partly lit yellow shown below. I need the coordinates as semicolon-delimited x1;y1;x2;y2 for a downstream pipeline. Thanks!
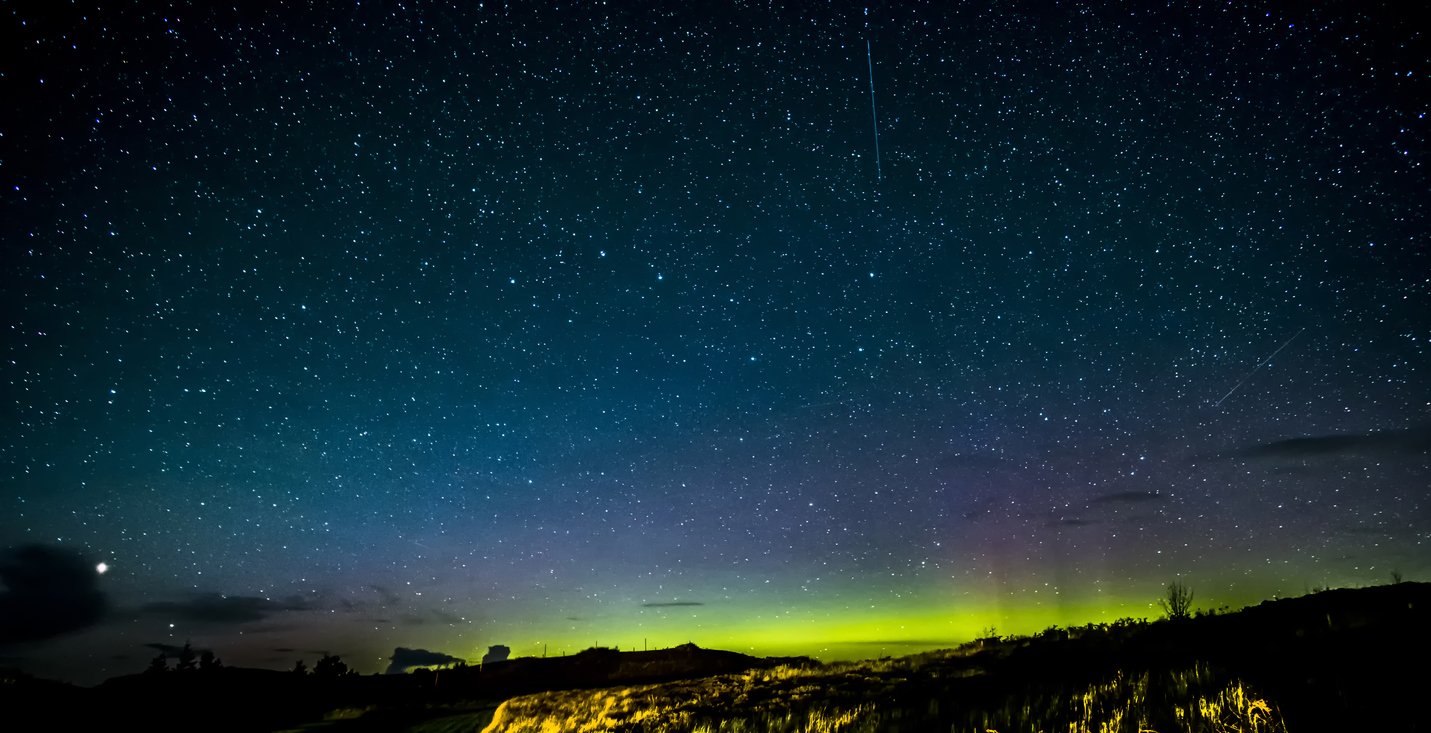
485;584;1431;733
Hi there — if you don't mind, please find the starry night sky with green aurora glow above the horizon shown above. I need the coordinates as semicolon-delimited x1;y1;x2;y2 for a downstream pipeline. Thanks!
0;1;1431;683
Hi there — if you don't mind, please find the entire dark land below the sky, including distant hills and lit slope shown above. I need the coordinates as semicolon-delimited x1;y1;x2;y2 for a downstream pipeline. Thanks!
0;583;1431;733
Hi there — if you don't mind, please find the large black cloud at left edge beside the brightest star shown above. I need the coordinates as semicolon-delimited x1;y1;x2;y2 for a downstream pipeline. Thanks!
0;544;109;646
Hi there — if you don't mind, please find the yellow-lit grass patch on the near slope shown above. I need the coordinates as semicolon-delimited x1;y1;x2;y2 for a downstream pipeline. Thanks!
484;656;1285;733
